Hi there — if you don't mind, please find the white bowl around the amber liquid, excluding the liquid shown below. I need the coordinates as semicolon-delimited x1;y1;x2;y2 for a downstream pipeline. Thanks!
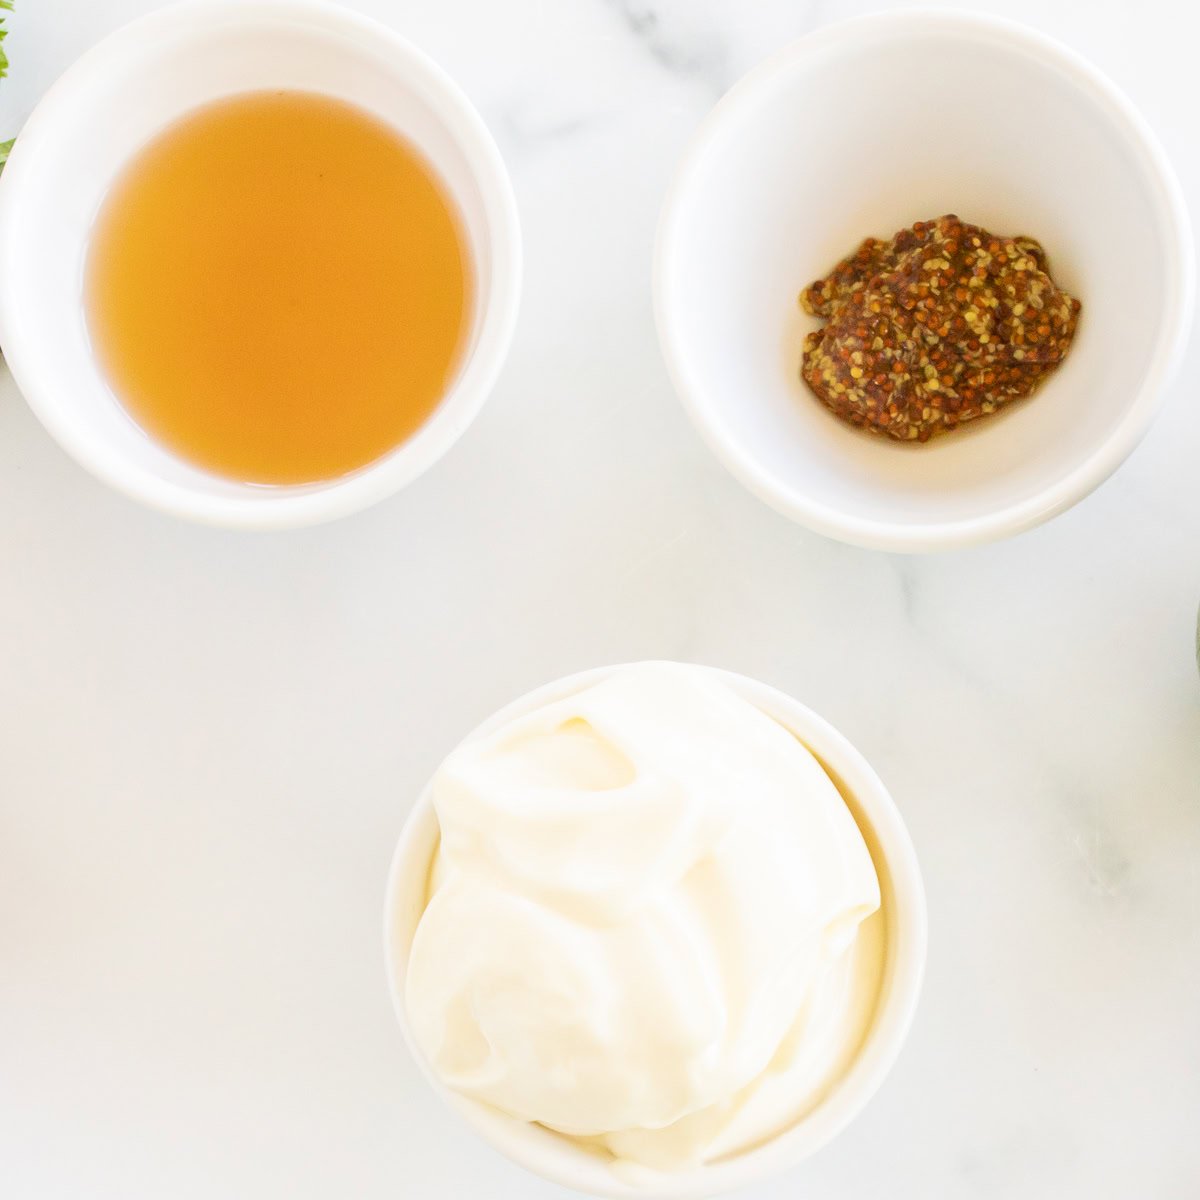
0;0;521;528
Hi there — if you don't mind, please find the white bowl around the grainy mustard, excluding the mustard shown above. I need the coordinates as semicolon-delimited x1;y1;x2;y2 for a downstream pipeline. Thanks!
655;11;1194;551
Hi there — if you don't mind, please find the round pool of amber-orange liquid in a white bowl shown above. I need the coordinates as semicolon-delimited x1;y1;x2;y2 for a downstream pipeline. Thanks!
84;92;472;484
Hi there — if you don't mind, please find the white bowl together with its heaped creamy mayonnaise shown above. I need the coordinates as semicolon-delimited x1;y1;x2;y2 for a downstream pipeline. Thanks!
385;662;926;1198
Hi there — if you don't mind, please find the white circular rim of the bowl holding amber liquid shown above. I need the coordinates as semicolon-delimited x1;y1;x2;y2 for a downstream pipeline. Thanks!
0;0;522;529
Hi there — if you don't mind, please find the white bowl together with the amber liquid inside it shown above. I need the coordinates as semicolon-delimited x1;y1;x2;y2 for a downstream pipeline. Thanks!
0;0;520;528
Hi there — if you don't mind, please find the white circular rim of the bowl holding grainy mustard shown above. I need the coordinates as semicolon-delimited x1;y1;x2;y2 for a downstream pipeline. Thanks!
652;7;1195;553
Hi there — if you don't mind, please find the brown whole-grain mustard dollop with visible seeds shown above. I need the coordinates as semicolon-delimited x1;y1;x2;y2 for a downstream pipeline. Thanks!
800;215;1080;442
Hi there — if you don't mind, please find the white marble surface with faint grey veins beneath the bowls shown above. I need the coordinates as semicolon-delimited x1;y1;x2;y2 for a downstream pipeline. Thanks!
0;0;1200;1200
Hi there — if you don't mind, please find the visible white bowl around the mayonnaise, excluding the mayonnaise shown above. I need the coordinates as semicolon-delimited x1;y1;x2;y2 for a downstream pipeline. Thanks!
384;667;928;1200
